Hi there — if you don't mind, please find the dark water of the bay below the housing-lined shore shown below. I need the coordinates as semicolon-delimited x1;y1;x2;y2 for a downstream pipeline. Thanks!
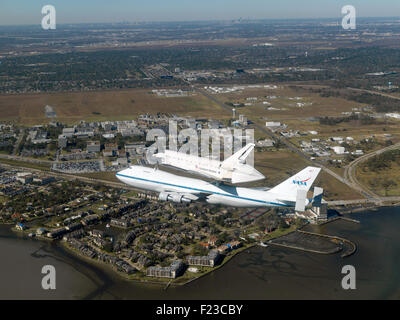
0;207;400;300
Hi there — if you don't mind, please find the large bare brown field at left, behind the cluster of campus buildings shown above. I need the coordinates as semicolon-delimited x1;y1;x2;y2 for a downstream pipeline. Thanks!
0;89;226;125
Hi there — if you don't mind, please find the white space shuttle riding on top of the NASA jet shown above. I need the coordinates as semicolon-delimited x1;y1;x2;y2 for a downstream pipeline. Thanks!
154;143;265;184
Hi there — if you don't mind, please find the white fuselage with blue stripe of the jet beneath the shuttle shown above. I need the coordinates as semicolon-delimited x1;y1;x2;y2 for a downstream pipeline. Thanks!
116;166;295;207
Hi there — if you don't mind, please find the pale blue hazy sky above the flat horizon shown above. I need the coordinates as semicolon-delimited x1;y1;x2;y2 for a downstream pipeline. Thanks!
0;0;400;25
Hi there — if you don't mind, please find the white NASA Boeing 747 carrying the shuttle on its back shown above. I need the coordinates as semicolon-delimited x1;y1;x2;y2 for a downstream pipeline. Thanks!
116;166;322;211
